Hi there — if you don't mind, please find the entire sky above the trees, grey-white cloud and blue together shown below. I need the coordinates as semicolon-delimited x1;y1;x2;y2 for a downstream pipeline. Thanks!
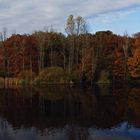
0;0;140;34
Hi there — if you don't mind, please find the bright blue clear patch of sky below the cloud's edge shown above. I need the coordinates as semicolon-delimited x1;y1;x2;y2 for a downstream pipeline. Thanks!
90;8;140;35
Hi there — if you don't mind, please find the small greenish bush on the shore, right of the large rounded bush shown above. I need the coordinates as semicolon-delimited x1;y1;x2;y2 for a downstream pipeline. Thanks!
97;70;110;84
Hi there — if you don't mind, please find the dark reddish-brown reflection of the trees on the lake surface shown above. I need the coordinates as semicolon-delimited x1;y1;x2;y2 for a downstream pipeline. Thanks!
0;86;139;135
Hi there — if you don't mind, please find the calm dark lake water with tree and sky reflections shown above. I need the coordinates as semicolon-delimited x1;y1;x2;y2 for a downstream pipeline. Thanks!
0;85;140;140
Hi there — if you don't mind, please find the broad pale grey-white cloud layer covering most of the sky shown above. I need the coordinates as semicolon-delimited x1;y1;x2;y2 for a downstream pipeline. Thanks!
0;0;140;33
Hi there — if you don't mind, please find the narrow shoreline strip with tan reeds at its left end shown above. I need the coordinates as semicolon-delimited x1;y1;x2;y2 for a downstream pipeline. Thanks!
0;77;140;87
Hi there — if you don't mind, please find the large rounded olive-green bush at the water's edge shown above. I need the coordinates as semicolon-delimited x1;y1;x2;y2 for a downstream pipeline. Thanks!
34;67;66;84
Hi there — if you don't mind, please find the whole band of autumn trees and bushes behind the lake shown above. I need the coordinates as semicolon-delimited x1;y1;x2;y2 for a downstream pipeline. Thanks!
0;17;140;84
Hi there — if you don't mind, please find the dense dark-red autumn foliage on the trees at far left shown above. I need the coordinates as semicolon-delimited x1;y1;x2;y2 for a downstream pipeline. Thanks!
5;35;38;76
